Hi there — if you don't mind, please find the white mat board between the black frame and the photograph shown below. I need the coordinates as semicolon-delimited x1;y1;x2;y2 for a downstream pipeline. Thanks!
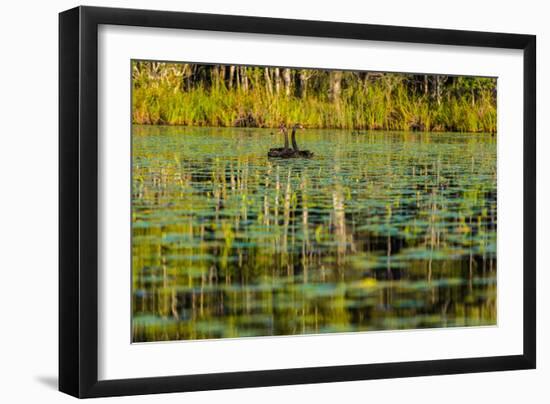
98;26;523;380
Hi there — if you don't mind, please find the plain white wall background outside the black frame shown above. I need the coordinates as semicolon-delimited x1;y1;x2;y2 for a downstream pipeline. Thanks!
0;0;550;403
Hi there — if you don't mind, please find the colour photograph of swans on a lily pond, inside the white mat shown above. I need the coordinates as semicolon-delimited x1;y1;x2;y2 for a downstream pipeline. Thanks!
131;60;498;343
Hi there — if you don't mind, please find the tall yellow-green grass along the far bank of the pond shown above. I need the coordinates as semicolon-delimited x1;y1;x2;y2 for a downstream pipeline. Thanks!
132;71;496;132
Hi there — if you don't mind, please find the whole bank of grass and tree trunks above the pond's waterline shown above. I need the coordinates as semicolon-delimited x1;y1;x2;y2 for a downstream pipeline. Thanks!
132;61;497;133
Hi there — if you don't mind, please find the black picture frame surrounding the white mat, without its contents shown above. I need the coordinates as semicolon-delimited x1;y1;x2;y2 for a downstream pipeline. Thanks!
59;7;536;398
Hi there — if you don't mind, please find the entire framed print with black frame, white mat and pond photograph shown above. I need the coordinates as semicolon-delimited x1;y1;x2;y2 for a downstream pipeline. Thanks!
59;7;536;397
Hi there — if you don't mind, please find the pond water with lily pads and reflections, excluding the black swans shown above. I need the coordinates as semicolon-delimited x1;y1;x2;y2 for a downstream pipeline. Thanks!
132;126;497;342
